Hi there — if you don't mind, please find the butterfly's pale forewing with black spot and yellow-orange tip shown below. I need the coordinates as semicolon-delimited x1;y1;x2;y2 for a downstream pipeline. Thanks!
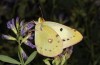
45;21;83;48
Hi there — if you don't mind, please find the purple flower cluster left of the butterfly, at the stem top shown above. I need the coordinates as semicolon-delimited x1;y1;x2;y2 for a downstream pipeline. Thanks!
2;17;35;48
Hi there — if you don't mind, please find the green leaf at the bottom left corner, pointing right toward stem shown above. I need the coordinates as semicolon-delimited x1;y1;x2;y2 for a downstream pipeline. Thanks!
0;55;21;64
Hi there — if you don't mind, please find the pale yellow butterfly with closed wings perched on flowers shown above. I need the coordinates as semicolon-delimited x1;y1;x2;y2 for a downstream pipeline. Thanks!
35;18;83;57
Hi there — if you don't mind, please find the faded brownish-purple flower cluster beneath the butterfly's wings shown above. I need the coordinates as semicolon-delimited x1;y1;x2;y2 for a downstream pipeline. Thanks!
52;46;73;65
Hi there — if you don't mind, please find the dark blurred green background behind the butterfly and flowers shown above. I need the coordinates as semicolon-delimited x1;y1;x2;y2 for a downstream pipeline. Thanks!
0;0;100;65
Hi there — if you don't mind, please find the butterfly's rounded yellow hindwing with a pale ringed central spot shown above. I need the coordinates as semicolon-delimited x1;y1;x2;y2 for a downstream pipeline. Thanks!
35;23;63;57
